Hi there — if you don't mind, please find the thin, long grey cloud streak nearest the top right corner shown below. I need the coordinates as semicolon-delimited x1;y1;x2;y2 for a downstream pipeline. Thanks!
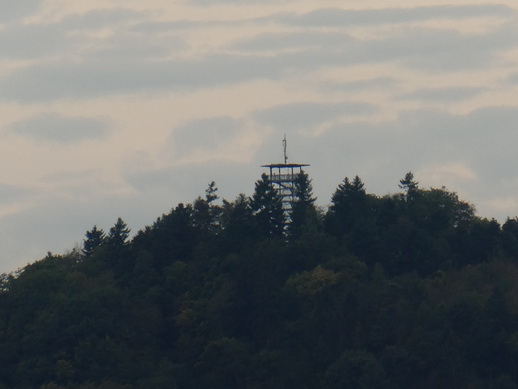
277;4;515;27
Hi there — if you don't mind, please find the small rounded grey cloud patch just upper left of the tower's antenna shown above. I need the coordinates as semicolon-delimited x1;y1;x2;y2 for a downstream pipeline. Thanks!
172;116;243;156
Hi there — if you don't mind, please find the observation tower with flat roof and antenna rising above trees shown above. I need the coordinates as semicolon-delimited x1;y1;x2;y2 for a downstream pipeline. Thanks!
261;135;310;215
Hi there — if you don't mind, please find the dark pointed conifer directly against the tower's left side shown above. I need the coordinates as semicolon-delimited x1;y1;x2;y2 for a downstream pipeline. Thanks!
250;174;285;236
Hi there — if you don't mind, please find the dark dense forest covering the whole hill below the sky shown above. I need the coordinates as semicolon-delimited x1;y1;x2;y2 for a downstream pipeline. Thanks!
0;172;518;389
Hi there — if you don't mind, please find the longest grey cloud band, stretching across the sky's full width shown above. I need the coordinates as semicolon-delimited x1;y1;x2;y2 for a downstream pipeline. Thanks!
0;15;517;102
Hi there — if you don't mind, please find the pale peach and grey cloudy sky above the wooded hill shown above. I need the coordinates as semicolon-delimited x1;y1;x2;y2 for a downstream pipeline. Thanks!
0;0;518;272
